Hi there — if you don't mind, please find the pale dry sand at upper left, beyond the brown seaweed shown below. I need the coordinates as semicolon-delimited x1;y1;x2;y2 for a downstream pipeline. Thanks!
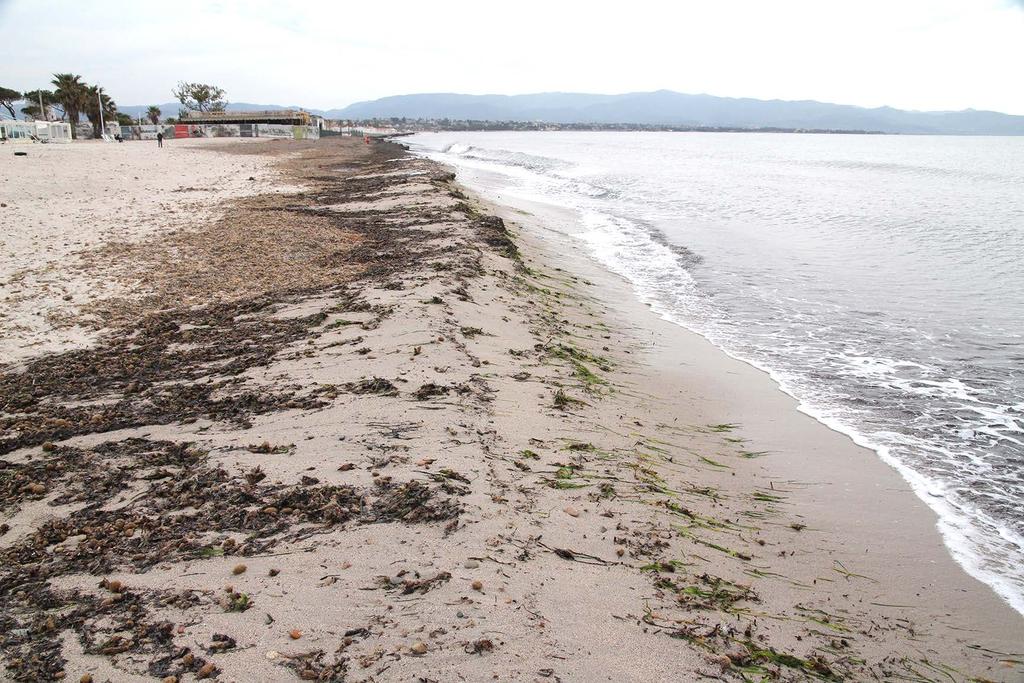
0;139;296;361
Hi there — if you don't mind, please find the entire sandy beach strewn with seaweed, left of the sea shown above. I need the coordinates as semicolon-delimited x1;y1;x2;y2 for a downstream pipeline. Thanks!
0;138;1024;683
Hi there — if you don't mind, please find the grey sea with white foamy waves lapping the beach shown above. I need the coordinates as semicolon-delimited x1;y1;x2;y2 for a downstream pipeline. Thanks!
409;132;1024;613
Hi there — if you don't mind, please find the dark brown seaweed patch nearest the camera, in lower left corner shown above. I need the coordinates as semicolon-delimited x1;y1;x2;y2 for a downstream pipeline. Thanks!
0;438;461;680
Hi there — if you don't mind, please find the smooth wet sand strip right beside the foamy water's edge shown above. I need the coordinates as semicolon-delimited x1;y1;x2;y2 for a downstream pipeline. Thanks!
490;189;1024;631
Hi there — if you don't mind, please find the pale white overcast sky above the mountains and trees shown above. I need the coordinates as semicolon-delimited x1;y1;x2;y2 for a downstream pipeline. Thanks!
6;0;1024;115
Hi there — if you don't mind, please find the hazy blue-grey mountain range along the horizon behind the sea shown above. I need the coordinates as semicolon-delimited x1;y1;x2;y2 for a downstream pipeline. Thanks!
108;90;1024;135
